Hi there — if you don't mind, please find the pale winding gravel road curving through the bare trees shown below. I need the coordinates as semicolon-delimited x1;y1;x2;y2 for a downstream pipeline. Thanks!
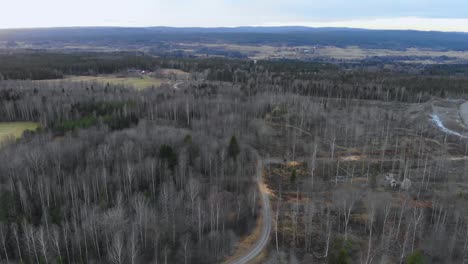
229;158;272;264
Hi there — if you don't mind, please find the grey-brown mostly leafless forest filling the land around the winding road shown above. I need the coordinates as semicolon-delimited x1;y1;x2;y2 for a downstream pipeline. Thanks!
0;52;468;264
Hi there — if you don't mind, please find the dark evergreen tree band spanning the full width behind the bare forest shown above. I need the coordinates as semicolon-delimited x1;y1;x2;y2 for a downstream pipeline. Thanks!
0;53;468;102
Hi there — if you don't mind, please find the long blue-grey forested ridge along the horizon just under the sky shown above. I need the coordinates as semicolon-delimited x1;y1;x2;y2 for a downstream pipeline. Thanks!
0;27;468;51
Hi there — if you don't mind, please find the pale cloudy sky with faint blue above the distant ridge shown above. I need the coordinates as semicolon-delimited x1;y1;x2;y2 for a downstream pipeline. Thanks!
0;0;468;32
